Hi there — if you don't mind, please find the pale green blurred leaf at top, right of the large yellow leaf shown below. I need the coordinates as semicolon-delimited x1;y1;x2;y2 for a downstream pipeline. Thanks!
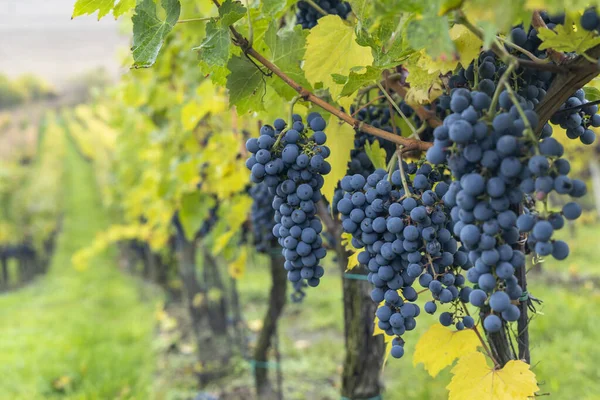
406;16;454;58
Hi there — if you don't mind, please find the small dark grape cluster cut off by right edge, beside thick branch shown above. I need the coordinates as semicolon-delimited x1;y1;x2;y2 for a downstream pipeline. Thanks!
550;89;600;144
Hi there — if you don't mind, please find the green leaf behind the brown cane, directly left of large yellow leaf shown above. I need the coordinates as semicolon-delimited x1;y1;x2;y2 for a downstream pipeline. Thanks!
264;21;311;100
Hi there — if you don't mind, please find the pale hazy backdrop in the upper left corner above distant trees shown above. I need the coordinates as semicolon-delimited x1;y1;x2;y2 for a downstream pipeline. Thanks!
0;0;129;86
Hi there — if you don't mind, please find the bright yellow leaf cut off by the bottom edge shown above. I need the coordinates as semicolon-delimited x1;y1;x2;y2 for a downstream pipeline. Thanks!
446;352;539;400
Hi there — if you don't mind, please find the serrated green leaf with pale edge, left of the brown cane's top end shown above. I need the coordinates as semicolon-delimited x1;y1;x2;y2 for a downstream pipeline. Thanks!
131;0;181;68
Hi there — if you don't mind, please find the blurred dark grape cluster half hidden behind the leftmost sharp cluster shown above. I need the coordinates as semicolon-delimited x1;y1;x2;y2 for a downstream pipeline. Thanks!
250;182;275;253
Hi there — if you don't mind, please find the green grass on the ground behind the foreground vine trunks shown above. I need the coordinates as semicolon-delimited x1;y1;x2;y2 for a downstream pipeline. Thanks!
233;248;600;400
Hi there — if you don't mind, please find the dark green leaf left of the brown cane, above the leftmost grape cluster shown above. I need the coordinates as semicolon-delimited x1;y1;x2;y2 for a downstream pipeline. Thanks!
227;56;265;114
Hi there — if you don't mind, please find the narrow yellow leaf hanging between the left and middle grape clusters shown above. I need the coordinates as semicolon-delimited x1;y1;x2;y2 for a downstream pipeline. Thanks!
322;116;354;203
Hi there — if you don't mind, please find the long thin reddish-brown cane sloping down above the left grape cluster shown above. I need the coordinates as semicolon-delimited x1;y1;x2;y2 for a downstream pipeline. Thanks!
213;0;433;151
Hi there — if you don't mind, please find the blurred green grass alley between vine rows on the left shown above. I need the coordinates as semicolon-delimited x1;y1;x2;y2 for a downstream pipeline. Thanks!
0;137;159;399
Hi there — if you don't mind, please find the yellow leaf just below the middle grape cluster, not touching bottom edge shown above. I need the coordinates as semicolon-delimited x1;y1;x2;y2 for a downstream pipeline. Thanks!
413;324;480;378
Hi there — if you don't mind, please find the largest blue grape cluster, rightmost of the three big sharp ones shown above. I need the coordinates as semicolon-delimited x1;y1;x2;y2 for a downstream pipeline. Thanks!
427;85;585;332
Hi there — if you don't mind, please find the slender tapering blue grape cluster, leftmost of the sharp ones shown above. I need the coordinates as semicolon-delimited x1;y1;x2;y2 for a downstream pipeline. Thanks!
246;113;331;288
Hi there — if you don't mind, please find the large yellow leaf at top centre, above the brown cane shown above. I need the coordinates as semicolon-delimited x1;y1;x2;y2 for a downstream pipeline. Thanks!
303;15;373;104
